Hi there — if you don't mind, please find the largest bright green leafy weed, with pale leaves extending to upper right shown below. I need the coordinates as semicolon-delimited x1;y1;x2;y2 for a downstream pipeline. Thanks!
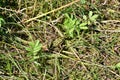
63;11;98;38
